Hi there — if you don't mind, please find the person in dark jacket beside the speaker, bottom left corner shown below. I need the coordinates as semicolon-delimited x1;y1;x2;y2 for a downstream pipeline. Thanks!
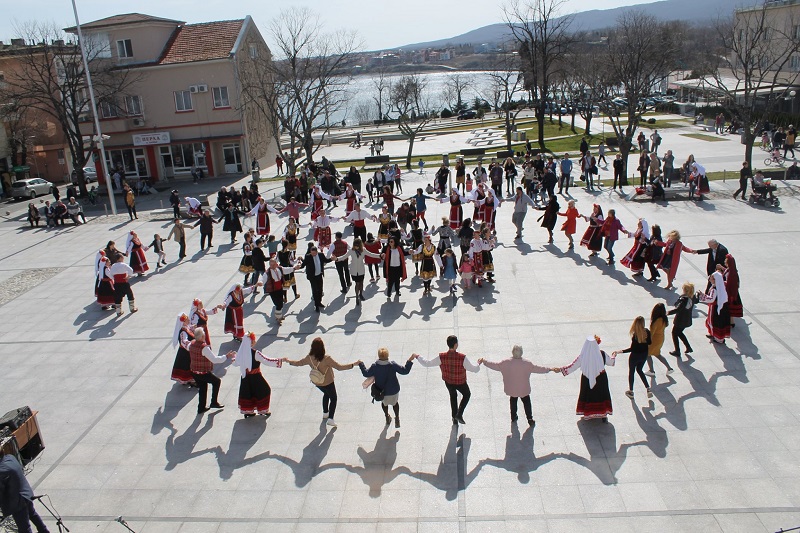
0;450;50;533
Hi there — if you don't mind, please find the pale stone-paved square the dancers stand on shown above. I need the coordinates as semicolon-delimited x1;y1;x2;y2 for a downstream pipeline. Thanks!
0;168;800;533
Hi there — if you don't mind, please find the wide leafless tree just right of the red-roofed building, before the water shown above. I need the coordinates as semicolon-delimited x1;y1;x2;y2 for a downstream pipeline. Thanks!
241;8;361;173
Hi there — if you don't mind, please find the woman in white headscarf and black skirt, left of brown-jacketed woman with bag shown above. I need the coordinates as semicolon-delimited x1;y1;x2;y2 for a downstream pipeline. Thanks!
236;331;283;418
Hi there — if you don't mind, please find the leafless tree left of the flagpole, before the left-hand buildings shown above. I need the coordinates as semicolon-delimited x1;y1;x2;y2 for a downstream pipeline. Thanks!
2;22;142;195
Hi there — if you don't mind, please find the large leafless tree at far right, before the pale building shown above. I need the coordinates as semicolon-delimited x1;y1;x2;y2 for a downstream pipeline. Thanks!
705;5;800;164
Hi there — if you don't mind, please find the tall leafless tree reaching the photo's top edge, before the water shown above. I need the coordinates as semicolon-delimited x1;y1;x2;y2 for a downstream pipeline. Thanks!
503;0;574;149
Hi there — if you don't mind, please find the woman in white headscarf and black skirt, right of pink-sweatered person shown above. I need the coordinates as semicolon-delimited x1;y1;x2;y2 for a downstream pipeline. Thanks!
553;335;615;422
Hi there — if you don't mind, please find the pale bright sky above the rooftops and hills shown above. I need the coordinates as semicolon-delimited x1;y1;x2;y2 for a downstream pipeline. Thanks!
0;0;653;50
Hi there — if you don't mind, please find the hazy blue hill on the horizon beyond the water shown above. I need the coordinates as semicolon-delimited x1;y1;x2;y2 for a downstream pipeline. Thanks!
398;0;757;50
